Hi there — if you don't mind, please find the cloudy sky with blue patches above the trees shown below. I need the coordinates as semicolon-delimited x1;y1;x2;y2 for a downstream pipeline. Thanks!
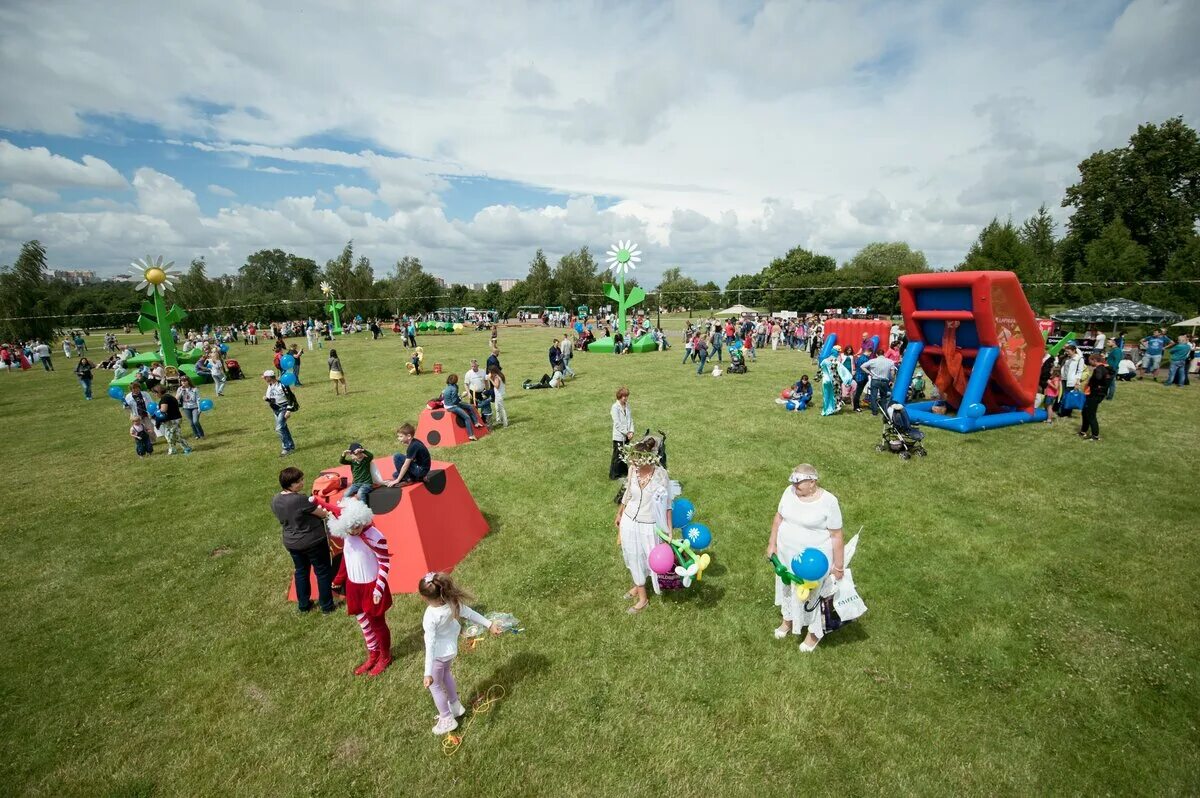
0;0;1200;284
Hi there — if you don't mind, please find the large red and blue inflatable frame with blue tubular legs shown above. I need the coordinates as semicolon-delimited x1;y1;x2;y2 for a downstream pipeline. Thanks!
892;271;1046;432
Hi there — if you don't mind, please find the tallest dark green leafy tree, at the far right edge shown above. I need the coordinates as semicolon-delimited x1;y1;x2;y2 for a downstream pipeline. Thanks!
1062;116;1200;278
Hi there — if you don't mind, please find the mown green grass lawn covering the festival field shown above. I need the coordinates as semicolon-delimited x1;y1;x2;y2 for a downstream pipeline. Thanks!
0;323;1200;796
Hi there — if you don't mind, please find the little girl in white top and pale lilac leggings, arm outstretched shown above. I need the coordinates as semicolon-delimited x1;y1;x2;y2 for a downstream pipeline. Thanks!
416;571;503;734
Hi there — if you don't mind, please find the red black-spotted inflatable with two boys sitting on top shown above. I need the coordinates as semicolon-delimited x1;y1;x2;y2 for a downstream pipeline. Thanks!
288;457;487;601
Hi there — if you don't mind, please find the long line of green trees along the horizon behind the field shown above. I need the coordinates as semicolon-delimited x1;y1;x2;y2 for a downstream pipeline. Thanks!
0;118;1200;338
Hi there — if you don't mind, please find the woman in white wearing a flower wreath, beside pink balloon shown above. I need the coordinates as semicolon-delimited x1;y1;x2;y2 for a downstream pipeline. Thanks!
613;438;671;614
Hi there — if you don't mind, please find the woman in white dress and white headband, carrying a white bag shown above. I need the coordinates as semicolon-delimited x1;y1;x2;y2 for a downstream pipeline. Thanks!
767;463;845;652
